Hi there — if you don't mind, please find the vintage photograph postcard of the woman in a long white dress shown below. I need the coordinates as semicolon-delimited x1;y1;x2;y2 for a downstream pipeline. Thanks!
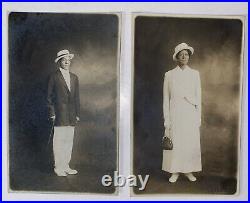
132;14;245;195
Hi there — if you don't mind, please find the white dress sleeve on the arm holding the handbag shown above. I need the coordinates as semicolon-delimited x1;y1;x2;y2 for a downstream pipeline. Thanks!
163;73;171;129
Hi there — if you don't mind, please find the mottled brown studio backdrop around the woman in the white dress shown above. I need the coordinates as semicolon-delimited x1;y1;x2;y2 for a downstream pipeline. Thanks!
133;16;242;194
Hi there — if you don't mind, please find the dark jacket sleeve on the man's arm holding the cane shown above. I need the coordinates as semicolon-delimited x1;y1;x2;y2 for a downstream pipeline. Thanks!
47;75;55;118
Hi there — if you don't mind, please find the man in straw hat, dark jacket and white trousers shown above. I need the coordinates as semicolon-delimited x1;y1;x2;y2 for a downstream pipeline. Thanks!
47;50;80;176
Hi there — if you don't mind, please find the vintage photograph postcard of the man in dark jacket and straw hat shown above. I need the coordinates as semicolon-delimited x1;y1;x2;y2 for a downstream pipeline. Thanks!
8;12;121;194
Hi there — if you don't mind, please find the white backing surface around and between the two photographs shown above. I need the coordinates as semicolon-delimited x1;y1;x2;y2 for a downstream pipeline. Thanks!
2;2;248;201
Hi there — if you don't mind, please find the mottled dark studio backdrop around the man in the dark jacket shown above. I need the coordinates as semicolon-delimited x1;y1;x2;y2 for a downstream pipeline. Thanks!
9;13;119;192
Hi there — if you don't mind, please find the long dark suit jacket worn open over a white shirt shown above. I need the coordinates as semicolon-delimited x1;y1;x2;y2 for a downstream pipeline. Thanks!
47;69;80;126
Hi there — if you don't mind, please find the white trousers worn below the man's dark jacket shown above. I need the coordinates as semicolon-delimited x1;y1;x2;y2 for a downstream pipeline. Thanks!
53;126;75;170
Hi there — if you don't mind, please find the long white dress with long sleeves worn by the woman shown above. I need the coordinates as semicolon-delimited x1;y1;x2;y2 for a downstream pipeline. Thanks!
162;66;202;173
